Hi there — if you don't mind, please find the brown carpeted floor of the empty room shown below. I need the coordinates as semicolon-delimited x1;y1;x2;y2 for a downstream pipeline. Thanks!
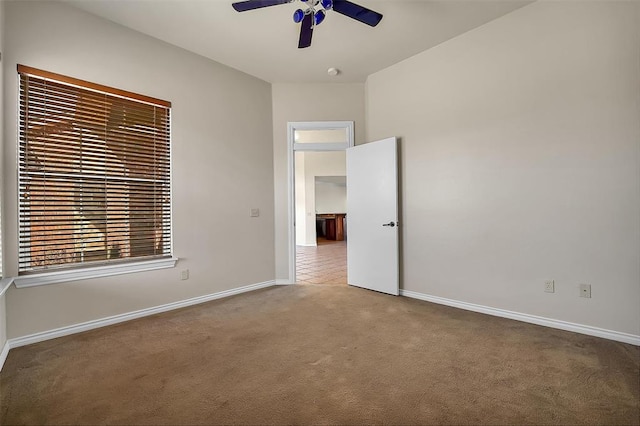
0;285;640;425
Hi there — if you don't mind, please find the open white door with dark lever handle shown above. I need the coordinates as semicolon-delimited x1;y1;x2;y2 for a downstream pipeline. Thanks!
347;138;399;295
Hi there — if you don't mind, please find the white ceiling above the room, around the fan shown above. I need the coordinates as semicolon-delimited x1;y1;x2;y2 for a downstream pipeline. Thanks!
68;0;531;83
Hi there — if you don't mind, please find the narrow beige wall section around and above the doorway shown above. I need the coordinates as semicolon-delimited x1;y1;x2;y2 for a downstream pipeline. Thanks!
272;83;365;281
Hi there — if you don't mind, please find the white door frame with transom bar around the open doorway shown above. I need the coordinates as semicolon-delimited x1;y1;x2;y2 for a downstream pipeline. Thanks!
287;121;354;284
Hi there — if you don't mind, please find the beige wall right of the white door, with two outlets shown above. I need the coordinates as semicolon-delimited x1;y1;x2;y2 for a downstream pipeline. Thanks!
366;1;640;336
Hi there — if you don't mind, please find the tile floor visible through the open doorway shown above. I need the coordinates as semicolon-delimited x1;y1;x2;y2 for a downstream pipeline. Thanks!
296;238;347;285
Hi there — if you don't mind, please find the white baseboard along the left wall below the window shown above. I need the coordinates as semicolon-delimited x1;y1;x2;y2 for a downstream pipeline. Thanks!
0;280;275;370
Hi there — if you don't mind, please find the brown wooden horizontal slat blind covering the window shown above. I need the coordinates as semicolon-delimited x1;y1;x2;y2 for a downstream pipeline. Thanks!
18;66;171;274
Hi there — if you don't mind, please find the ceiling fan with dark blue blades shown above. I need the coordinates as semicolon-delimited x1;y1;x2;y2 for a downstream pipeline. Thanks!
232;0;382;49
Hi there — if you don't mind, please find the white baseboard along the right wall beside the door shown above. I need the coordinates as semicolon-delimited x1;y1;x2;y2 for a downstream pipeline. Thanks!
400;290;640;346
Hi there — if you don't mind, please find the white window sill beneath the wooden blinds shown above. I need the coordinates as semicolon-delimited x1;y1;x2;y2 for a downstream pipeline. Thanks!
13;257;178;288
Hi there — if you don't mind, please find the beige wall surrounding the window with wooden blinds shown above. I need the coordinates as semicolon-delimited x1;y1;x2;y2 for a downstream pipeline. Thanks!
3;2;275;338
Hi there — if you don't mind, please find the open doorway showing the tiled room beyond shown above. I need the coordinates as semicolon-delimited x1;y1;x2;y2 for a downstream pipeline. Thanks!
288;122;353;285
